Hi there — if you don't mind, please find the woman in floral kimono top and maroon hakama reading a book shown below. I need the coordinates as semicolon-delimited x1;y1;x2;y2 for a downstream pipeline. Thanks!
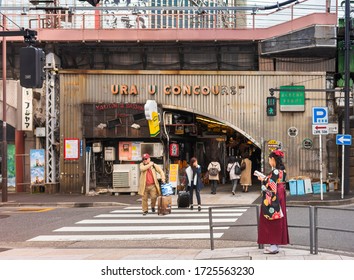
255;150;289;254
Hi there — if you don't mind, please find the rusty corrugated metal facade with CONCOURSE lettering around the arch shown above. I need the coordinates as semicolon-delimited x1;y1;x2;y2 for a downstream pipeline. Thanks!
60;70;327;193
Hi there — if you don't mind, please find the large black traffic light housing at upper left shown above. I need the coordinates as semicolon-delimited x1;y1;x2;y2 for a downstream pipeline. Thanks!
20;46;45;88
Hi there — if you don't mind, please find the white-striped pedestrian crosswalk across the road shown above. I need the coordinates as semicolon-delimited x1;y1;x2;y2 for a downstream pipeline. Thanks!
28;206;247;242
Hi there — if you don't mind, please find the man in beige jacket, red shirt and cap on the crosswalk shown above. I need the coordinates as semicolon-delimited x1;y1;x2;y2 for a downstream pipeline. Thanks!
138;154;166;216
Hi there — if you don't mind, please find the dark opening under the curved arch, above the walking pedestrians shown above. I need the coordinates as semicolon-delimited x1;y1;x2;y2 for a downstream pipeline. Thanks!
163;109;261;183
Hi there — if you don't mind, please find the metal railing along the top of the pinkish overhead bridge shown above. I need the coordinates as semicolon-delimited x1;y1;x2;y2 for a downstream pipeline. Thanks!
1;0;340;30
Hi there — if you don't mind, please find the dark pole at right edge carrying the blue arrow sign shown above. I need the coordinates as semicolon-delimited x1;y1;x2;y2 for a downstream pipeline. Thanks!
342;0;352;195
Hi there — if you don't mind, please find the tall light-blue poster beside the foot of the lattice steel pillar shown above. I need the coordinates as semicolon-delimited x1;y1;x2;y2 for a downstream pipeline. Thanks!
30;149;45;185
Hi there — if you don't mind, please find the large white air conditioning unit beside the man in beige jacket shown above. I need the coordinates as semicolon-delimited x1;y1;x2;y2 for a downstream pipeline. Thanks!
112;164;140;193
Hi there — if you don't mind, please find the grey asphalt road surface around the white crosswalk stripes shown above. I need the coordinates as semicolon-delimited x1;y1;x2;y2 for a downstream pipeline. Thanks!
0;205;354;252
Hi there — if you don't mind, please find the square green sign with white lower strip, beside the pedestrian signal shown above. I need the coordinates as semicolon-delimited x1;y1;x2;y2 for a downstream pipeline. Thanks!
279;86;305;112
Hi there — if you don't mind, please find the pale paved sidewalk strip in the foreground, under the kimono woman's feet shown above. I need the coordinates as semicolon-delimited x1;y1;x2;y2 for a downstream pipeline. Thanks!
0;245;354;261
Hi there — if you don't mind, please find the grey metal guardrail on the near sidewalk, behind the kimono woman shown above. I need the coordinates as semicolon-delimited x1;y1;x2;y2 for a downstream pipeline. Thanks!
209;204;354;254
